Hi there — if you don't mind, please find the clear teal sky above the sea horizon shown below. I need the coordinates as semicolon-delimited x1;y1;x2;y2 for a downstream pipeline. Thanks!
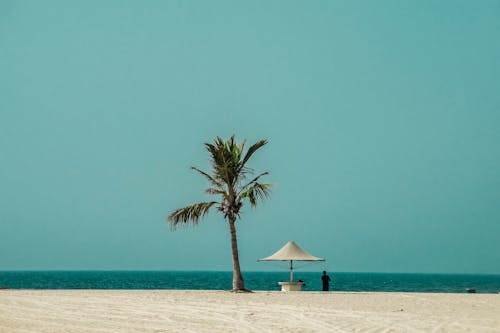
0;0;500;274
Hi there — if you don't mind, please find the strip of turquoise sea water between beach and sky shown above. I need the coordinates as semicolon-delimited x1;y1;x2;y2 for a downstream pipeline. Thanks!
0;271;500;293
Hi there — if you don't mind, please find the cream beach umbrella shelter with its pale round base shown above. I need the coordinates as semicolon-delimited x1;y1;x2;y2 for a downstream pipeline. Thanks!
259;242;325;291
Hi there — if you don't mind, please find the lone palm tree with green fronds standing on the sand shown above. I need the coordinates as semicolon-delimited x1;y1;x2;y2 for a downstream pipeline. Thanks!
167;135;271;291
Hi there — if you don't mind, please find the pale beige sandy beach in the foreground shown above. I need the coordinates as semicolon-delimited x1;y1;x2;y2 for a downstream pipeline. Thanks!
0;290;500;333
